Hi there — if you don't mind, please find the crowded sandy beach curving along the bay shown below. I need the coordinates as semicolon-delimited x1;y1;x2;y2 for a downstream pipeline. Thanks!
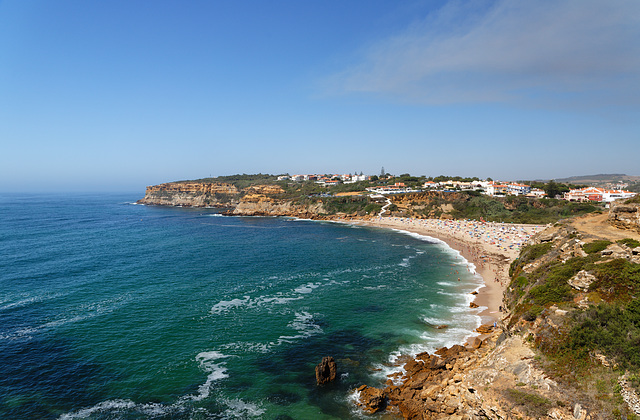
350;217;547;324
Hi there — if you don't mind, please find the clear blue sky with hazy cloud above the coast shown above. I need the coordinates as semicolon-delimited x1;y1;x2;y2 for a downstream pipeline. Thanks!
0;0;640;193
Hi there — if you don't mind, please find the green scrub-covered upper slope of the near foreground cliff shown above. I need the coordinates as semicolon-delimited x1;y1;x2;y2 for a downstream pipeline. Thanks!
505;220;640;418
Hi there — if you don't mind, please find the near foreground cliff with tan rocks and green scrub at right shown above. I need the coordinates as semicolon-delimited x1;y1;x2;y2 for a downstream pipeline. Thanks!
356;212;640;420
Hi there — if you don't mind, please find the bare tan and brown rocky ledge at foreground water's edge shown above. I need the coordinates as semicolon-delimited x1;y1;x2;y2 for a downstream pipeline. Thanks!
356;326;576;420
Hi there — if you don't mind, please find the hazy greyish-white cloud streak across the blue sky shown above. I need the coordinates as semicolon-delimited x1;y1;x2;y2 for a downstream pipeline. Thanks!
329;0;640;107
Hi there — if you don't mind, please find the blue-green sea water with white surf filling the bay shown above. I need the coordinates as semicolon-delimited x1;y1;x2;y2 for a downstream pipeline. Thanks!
0;194;481;419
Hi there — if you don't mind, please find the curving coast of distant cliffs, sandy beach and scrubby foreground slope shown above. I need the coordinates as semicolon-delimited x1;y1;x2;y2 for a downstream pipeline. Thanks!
140;182;640;420
